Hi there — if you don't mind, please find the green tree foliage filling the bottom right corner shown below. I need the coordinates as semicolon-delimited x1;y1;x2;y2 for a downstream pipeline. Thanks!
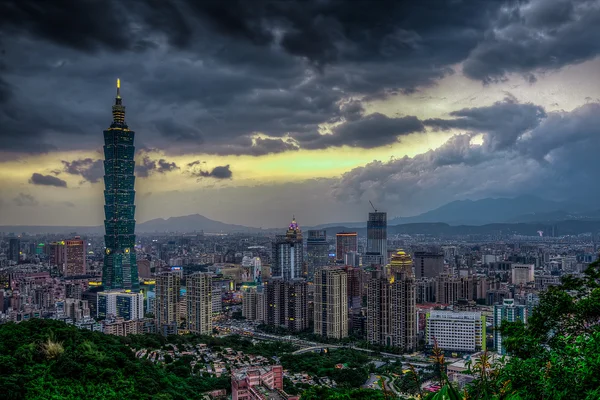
425;261;600;400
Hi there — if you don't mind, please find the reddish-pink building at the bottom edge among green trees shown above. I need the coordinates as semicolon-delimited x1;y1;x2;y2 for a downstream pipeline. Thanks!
231;365;299;400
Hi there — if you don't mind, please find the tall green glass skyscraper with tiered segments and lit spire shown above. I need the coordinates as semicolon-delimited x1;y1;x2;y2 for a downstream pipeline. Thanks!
102;80;139;291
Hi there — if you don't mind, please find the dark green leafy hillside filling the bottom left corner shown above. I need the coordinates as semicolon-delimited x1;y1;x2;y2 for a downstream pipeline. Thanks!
0;319;230;400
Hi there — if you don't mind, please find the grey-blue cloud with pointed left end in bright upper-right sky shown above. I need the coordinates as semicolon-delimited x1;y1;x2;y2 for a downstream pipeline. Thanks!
424;98;546;150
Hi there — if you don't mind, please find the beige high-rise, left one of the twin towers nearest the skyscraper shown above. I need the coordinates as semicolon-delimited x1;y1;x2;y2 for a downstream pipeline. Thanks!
154;272;181;330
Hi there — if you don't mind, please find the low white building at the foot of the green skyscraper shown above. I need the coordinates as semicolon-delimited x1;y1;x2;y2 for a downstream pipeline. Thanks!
97;291;144;321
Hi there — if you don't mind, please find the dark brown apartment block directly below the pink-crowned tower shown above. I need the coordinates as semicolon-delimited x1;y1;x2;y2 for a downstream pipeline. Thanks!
264;279;308;332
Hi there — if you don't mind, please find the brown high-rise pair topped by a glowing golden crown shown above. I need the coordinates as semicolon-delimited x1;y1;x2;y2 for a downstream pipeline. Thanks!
367;251;417;351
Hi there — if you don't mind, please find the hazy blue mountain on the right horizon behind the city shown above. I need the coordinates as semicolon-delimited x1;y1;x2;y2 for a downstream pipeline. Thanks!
388;196;585;225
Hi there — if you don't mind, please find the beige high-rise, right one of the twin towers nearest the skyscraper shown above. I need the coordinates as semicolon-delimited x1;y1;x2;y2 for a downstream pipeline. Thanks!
186;273;212;335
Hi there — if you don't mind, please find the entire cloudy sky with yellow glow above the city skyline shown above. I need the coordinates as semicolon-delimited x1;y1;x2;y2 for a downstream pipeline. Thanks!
0;0;600;227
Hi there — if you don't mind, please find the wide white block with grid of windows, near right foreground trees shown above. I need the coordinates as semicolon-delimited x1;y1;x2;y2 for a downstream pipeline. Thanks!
425;310;486;352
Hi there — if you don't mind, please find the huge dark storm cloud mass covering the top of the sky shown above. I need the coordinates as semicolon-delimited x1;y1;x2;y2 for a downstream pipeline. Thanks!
0;0;600;159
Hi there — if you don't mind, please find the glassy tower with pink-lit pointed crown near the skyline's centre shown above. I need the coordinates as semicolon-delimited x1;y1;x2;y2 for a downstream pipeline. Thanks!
271;218;304;280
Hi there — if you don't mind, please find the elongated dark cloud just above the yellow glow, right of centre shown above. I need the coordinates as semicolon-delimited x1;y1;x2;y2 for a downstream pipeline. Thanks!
297;113;425;149
